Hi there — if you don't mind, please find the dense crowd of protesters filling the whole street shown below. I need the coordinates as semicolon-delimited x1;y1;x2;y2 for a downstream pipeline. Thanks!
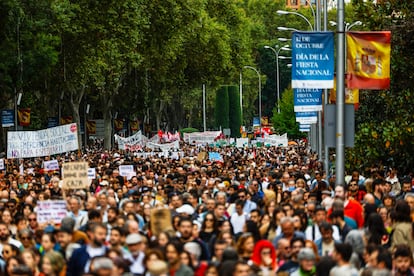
0;144;414;276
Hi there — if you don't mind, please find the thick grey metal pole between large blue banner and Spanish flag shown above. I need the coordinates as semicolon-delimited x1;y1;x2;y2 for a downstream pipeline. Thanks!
335;0;345;185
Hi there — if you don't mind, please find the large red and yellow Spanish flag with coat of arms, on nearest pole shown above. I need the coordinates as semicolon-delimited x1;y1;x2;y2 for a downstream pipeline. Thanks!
347;31;391;90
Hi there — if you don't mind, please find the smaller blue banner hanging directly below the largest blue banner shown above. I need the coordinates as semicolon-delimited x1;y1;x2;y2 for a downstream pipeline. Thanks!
293;88;322;112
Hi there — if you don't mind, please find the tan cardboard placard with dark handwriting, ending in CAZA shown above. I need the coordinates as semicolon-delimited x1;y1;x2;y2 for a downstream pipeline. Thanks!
62;162;90;189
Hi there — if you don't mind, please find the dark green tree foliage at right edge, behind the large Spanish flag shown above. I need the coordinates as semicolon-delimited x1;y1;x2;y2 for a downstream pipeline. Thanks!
347;0;414;175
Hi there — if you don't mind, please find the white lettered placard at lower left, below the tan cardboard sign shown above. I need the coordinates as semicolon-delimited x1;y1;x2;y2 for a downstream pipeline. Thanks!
37;200;68;224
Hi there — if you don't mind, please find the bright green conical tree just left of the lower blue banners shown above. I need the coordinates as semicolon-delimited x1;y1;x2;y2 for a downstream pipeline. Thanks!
272;89;305;139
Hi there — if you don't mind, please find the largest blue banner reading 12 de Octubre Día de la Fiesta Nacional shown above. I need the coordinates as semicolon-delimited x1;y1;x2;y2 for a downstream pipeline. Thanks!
292;32;335;89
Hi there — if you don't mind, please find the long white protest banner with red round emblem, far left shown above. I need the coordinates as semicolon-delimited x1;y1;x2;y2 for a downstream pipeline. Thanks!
7;123;78;158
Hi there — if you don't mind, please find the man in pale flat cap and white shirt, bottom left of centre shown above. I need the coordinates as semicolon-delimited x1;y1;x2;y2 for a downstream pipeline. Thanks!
125;233;145;275
